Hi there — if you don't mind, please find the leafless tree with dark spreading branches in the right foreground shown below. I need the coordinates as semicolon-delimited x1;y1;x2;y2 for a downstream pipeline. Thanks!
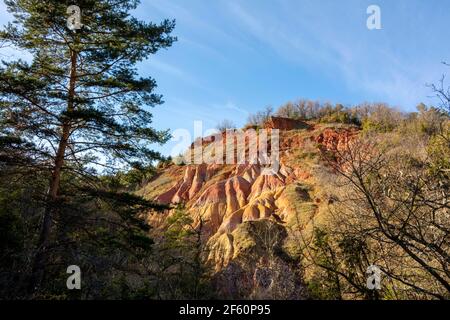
323;135;450;299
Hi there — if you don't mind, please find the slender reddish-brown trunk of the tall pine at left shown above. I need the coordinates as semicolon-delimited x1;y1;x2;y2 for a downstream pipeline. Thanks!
29;49;78;294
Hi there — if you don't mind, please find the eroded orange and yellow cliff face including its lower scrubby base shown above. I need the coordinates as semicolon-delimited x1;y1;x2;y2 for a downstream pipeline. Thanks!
141;122;358;298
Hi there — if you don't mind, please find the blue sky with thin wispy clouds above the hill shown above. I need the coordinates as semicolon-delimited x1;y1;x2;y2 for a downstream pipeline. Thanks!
0;0;450;152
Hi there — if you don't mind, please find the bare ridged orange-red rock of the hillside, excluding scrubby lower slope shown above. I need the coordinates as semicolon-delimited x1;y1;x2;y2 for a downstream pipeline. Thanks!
146;124;358;269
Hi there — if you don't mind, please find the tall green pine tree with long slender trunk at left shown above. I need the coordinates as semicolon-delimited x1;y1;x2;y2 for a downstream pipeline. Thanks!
0;0;176;296
